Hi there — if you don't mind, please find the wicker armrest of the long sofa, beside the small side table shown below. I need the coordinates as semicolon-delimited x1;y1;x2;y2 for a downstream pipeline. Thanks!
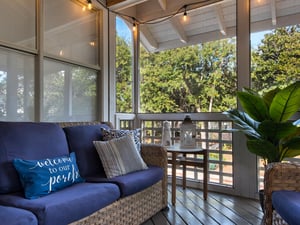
141;144;168;207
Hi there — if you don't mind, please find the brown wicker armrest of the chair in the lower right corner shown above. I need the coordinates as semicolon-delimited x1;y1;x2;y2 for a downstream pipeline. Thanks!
264;163;300;225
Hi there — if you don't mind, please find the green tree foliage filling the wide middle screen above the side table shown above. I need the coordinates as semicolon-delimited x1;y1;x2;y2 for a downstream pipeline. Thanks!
140;39;236;113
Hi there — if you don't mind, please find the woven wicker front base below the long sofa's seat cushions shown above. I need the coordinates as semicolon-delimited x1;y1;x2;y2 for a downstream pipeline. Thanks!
71;181;164;225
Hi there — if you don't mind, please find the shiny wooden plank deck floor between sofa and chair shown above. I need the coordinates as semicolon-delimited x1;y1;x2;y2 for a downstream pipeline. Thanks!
142;187;263;225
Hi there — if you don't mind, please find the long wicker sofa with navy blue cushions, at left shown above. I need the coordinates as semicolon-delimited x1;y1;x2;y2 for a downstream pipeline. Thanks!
0;122;167;225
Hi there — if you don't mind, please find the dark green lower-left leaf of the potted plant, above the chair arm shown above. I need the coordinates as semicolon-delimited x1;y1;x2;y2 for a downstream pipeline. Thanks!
247;139;280;163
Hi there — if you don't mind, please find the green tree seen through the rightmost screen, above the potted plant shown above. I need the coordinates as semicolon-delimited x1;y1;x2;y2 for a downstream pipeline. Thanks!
252;25;300;90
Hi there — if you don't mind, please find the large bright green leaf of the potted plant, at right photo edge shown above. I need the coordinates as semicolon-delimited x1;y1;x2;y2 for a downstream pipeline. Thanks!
270;81;300;122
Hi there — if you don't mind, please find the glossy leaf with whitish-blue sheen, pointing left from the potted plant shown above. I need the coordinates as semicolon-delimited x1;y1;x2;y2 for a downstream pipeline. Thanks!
223;109;260;138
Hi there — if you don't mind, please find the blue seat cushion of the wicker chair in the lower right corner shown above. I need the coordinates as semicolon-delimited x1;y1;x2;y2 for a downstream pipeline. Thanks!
272;191;300;225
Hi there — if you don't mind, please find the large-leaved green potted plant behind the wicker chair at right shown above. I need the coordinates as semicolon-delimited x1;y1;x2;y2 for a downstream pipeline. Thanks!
224;81;300;210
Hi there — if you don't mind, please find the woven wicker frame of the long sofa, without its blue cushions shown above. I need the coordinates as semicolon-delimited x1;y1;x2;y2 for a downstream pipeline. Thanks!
59;122;168;225
